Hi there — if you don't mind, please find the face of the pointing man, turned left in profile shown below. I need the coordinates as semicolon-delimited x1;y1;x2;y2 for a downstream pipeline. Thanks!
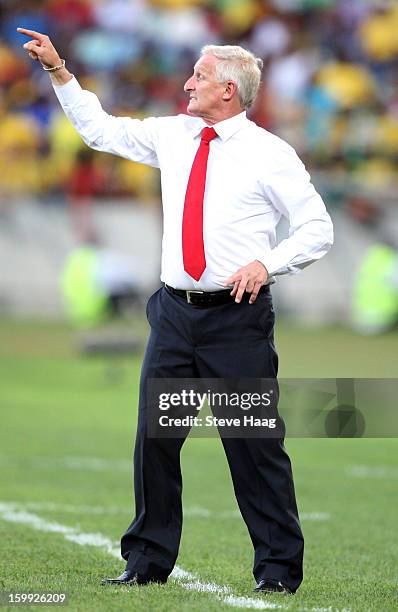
184;55;225;119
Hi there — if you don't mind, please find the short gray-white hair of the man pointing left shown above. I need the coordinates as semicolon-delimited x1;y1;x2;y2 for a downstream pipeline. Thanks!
201;45;263;108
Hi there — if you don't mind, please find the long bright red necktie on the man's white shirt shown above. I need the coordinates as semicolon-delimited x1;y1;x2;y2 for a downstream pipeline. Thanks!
182;128;217;281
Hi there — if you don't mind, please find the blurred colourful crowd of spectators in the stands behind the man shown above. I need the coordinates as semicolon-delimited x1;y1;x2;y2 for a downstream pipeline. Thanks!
0;0;398;202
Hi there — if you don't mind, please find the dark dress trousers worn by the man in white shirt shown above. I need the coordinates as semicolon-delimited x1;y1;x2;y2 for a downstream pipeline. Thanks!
121;288;304;591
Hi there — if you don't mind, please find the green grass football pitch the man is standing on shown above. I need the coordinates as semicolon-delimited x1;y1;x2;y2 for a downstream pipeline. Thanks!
0;320;398;612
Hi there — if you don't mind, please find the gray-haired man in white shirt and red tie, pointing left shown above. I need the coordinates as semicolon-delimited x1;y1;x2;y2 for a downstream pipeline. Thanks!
20;29;333;593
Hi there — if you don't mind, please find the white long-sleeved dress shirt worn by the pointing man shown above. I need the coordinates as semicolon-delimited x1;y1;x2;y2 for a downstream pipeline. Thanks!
54;78;333;291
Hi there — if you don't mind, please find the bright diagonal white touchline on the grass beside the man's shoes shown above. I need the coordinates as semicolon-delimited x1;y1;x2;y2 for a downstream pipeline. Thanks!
0;503;282;610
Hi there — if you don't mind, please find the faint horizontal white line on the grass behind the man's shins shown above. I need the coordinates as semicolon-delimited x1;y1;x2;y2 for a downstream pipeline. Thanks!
0;502;330;522
